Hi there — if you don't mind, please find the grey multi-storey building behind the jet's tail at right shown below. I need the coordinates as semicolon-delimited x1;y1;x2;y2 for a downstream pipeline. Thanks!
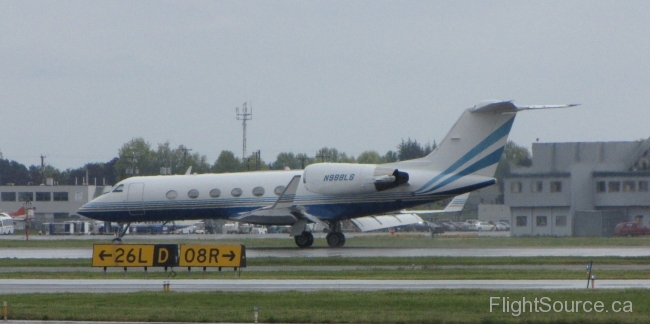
504;140;650;236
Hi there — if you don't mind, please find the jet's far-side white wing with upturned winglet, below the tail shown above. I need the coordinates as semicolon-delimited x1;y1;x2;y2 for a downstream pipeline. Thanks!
351;192;469;232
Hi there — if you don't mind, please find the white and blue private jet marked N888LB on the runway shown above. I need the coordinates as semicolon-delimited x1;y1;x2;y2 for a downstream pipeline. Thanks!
78;101;576;248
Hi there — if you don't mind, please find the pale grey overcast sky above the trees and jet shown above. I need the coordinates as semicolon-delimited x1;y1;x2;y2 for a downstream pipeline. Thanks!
0;0;650;170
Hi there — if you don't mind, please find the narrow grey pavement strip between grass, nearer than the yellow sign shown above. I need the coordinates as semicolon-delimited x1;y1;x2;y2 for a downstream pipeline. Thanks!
0;279;650;294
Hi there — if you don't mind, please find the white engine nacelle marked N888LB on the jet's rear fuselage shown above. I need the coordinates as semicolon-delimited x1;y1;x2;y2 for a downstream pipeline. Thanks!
302;163;409;195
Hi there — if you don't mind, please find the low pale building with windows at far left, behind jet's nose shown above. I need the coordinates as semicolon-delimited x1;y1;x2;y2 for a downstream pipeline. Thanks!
0;185;110;229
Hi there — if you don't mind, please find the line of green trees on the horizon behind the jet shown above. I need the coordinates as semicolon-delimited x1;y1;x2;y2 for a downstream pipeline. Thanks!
0;138;530;185
